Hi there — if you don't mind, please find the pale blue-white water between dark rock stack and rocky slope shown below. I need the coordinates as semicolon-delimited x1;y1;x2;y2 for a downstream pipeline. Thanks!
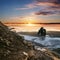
19;34;60;49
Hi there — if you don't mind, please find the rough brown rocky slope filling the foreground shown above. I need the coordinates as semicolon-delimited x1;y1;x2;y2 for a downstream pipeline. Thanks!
0;22;60;60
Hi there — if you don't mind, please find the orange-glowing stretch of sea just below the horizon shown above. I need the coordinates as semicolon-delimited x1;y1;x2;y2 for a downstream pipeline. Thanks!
7;24;60;32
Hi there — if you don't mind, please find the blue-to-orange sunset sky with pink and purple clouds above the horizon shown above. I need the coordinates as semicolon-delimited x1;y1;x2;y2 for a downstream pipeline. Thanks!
0;0;60;31
